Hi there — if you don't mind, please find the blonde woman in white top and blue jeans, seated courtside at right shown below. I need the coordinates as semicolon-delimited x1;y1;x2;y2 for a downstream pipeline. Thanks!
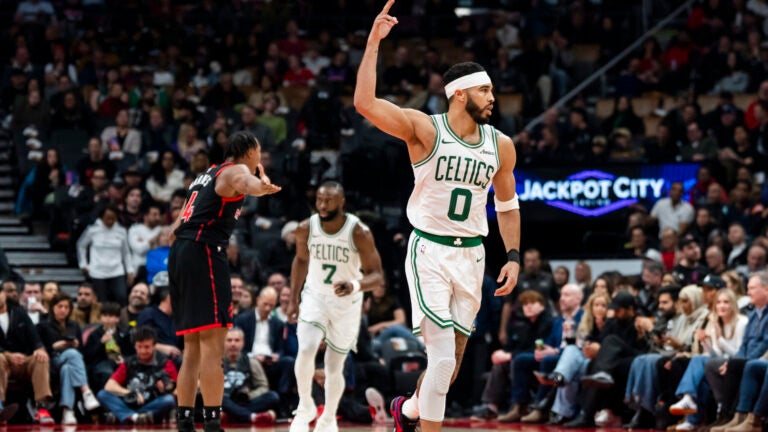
667;284;747;430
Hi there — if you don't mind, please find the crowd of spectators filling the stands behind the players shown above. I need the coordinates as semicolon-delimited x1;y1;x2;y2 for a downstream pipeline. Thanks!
0;0;768;430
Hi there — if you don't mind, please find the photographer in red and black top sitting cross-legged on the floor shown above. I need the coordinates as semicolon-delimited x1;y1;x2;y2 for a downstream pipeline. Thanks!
98;326;178;424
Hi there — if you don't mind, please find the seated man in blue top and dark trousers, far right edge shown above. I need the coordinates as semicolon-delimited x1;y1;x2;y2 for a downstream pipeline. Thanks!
704;271;768;426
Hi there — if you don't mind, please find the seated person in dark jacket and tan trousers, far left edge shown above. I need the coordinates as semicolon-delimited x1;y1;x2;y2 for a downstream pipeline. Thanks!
0;291;53;424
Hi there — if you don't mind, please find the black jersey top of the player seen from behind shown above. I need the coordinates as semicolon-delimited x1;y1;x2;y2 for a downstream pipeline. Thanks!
174;162;245;246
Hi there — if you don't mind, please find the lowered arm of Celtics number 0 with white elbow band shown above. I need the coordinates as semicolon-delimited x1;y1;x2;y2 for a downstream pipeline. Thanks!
493;133;520;296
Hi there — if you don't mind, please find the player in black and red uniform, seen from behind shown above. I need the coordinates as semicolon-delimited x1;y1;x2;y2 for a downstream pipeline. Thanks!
168;132;280;432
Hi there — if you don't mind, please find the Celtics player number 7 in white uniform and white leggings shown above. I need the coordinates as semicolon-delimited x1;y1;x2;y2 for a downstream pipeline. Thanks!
287;182;384;432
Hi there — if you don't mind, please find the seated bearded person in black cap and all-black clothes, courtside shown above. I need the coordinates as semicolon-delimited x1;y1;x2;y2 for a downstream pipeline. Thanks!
565;291;649;428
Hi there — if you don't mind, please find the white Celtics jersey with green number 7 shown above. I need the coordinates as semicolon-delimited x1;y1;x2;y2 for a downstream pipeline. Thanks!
305;213;363;295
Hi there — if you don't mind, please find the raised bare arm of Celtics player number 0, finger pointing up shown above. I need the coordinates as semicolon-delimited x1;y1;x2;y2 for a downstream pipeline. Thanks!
354;0;431;147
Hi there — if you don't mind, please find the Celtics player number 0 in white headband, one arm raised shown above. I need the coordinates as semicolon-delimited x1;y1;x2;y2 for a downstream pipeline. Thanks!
354;0;520;432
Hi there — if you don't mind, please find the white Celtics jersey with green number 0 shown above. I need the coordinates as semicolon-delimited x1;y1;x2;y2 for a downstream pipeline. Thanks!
407;114;499;237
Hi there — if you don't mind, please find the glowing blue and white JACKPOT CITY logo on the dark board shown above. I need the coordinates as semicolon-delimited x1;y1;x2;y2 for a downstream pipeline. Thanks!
518;170;665;217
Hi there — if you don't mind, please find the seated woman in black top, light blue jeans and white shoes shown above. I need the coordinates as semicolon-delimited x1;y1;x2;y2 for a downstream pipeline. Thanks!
38;293;99;424
